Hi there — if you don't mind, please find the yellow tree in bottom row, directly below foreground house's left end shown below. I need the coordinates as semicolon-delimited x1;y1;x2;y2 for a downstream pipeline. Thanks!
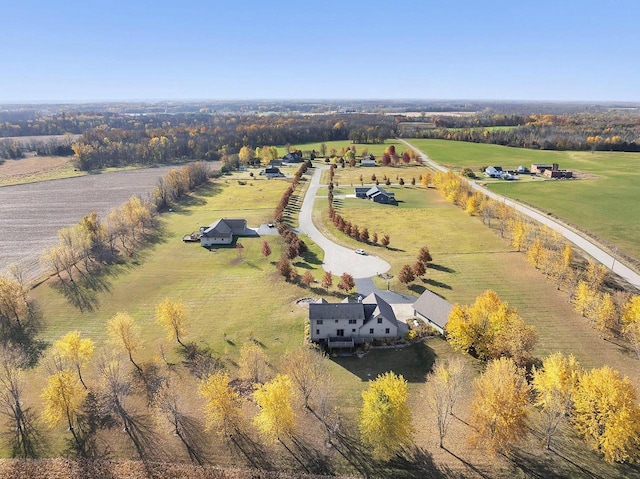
253;374;296;442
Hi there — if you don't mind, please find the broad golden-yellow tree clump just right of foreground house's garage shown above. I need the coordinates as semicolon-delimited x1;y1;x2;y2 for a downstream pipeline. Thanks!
446;290;537;364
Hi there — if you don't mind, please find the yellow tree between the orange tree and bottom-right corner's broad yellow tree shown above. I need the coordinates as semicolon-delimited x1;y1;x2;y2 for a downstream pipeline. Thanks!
533;353;580;449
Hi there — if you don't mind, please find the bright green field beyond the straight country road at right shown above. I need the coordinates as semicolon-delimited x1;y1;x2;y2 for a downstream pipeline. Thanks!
409;140;640;262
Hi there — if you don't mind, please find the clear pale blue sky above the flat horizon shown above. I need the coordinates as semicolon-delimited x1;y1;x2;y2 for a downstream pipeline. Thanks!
0;0;640;102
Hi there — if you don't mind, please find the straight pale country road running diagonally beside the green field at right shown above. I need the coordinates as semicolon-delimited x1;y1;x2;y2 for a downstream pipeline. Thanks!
398;139;640;289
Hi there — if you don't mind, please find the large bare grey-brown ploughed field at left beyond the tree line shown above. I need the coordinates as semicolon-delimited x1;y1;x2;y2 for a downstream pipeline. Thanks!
0;165;218;280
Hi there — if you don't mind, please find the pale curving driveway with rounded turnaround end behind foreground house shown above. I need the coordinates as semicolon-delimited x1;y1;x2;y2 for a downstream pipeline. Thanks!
299;166;390;278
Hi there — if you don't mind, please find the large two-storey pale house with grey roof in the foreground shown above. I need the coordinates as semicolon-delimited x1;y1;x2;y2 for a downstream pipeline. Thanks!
309;293;406;349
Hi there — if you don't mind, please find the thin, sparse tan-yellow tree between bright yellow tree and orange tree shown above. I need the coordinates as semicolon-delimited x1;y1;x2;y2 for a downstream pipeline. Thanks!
424;357;465;447
